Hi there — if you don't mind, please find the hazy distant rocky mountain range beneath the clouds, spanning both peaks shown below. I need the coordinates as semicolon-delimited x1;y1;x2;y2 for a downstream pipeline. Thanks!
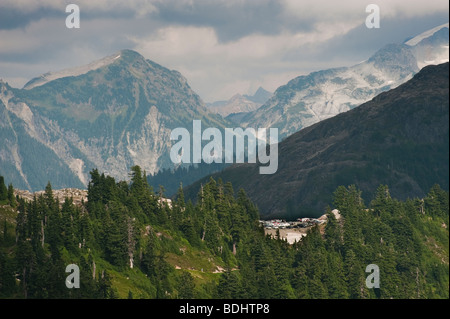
0;24;448;195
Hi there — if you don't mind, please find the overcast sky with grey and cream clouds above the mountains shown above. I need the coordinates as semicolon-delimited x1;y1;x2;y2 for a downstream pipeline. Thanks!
0;0;449;102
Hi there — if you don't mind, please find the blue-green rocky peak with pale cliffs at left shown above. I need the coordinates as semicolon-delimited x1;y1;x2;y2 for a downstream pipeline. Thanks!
0;50;225;190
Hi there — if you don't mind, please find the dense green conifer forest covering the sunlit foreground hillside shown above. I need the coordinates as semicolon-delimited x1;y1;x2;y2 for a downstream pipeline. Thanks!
0;170;449;299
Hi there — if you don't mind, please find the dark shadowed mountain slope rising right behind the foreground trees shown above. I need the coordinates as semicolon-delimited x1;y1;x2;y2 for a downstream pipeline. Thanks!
185;62;449;218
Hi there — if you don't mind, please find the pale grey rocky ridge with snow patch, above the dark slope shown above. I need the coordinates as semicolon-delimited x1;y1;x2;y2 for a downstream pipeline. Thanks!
240;24;449;138
